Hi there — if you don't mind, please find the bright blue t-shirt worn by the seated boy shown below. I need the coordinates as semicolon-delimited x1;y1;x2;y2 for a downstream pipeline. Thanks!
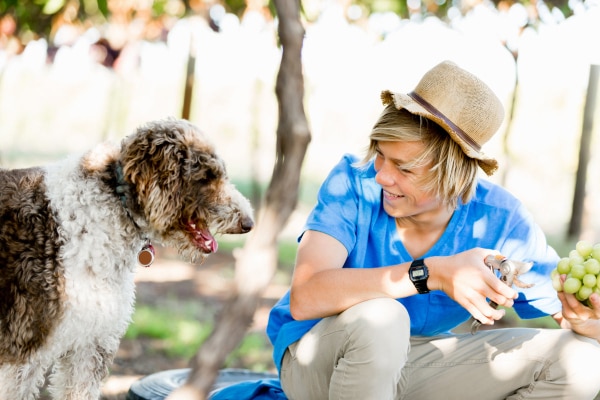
267;155;561;368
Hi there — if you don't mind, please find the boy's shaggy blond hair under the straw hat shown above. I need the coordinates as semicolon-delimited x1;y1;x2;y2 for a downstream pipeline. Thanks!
362;103;478;208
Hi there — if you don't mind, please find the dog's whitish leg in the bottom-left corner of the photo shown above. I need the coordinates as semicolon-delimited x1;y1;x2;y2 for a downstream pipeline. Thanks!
0;356;50;400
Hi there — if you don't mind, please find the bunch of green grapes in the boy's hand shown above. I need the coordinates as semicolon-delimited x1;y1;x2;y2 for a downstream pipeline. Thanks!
551;240;600;305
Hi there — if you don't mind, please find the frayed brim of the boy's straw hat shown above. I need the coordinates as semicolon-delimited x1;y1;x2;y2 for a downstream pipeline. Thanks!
381;90;498;175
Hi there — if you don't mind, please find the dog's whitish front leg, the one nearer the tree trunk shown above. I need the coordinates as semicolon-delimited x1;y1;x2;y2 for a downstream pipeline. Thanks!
50;346;116;400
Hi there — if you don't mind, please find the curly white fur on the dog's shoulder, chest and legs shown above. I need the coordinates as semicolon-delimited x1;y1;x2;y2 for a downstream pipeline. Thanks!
0;158;139;400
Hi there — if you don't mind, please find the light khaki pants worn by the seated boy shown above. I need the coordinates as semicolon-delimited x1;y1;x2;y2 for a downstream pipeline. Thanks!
281;299;600;400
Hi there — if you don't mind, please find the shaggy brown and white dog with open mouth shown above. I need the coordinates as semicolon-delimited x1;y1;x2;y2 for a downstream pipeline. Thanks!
0;119;254;400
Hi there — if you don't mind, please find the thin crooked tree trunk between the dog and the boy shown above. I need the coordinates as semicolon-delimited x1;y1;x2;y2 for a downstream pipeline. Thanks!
169;0;311;400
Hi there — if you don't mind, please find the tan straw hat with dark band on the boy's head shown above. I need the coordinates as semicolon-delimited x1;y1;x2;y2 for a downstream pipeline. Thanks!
381;61;504;175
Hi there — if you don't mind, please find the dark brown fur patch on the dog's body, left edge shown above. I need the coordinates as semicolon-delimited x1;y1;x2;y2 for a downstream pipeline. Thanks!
0;168;64;363
